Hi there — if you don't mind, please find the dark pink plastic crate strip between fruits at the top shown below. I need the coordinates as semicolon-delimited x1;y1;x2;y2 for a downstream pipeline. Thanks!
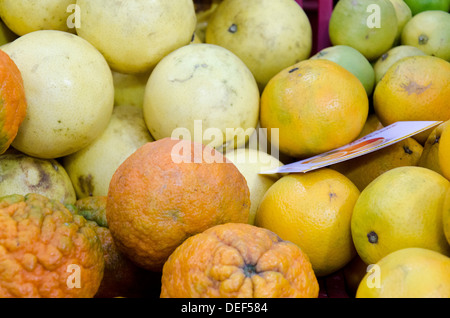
295;0;334;54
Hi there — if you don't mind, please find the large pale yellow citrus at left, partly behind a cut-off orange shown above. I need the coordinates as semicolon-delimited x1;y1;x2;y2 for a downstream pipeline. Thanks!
4;30;114;159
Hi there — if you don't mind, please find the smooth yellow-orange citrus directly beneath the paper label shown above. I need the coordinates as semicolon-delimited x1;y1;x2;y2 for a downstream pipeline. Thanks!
255;168;359;276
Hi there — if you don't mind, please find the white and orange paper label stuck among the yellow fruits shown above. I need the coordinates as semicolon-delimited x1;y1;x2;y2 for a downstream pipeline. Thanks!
260;121;442;174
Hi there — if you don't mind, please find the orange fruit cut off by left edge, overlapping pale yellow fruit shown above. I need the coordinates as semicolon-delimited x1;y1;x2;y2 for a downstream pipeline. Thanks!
0;50;27;154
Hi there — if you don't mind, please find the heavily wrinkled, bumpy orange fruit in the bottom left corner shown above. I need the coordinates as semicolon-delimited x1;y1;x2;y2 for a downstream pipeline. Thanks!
0;194;104;298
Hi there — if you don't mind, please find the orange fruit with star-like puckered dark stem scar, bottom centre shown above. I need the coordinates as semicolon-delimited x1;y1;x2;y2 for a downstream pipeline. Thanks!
161;223;319;298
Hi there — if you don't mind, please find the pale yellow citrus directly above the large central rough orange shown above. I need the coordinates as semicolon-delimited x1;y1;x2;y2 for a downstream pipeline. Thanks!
143;43;260;151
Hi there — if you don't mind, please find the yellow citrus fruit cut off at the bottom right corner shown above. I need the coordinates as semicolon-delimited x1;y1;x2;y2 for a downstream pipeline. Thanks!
356;247;450;298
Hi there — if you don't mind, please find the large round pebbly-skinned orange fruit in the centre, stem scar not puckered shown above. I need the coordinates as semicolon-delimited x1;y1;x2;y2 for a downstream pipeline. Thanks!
106;138;250;271
